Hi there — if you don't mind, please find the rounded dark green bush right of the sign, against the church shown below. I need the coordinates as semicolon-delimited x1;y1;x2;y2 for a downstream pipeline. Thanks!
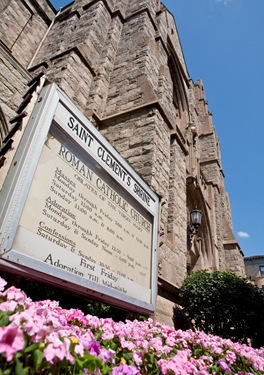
180;270;264;347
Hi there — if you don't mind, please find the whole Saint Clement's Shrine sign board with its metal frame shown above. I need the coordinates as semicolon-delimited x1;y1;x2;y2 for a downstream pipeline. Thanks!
0;84;158;311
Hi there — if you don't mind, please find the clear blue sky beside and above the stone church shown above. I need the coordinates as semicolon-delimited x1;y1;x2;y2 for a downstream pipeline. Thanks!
51;0;264;256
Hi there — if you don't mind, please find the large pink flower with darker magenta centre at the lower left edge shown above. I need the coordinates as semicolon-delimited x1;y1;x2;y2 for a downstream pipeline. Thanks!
0;325;25;362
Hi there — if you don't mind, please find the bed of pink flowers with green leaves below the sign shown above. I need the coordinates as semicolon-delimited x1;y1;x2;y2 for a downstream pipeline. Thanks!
0;278;264;375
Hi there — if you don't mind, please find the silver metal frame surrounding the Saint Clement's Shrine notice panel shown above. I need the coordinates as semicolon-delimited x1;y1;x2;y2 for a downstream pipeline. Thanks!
0;83;159;314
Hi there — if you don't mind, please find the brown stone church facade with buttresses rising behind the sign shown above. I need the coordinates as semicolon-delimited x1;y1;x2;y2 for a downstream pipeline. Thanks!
0;0;245;324
